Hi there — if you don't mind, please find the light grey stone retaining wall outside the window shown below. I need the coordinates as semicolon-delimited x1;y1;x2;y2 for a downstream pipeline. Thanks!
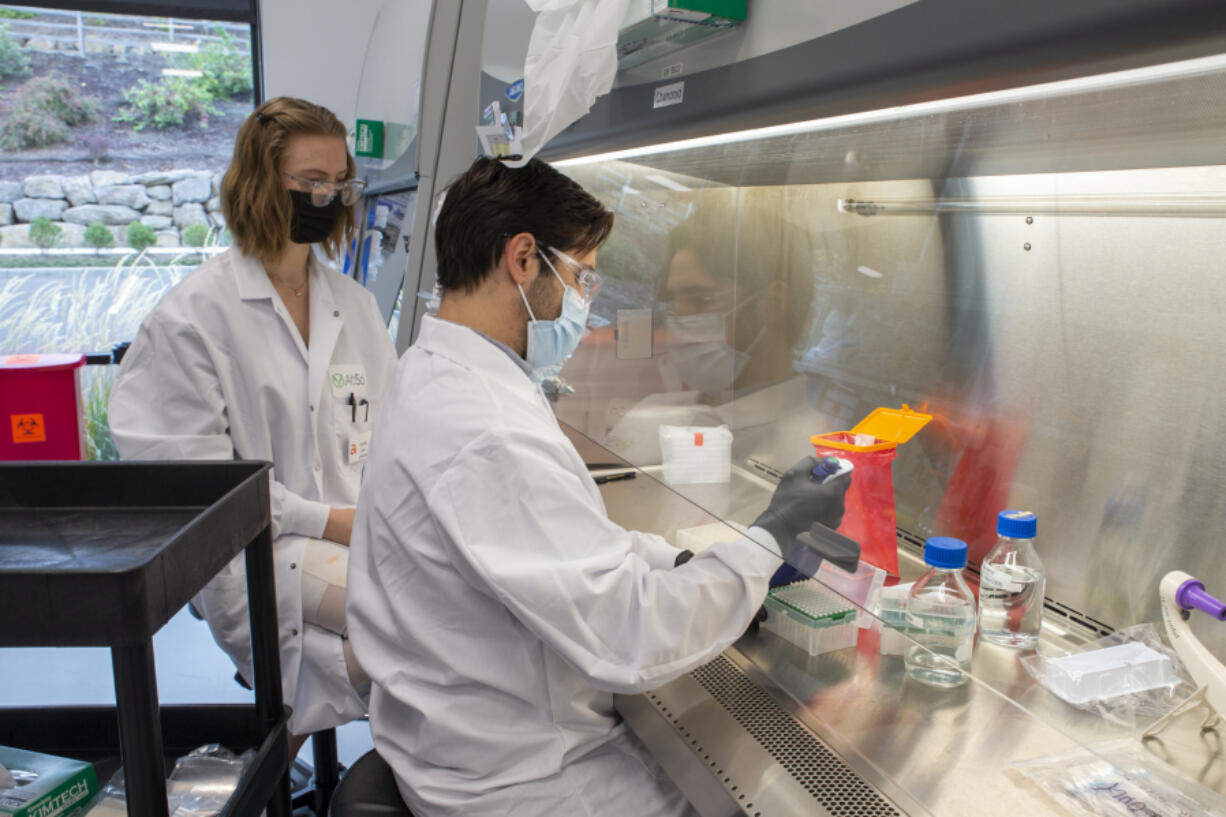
0;169;226;248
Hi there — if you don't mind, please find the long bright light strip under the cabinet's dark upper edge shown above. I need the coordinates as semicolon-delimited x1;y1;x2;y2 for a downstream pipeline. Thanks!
554;54;1226;167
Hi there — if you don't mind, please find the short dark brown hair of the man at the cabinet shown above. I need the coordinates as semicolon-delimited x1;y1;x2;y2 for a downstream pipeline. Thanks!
434;158;613;292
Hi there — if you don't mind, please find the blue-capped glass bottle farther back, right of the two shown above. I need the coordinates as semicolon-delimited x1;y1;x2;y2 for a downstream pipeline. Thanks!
980;510;1047;649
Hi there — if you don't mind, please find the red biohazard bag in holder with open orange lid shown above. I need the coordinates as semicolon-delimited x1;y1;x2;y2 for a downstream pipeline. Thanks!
809;405;932;575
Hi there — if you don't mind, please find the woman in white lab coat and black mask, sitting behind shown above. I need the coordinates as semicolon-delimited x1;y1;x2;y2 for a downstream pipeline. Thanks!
109;97;396;751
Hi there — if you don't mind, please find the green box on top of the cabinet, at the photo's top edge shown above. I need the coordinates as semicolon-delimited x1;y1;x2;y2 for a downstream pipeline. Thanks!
617;0;748;69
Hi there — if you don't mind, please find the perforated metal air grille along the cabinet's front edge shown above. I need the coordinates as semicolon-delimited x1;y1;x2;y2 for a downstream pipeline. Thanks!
691;655;901;817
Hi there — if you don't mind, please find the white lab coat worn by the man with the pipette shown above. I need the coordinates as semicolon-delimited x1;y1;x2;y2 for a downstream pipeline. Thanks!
348;316;781;817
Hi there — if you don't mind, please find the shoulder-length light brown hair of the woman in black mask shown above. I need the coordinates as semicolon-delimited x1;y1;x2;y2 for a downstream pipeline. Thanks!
221;97;357;261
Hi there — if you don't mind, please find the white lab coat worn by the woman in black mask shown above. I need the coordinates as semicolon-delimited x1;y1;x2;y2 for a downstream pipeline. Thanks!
109;249;396;735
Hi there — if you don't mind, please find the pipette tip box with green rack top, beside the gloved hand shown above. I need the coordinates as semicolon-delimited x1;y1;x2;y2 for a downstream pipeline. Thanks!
761;579;859;655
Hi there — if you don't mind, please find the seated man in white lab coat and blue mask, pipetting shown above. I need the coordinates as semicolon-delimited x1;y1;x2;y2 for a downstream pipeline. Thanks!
348;159;847;817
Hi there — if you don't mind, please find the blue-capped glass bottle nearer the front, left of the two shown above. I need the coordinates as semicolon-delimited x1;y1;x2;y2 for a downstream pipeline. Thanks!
904;536;976;687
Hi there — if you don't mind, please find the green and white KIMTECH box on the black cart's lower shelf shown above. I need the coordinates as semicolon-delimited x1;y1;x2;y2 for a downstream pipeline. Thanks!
0;746;98;817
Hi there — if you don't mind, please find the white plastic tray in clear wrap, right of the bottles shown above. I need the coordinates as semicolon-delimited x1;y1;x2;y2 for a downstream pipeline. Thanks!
1041;642;1179;705
